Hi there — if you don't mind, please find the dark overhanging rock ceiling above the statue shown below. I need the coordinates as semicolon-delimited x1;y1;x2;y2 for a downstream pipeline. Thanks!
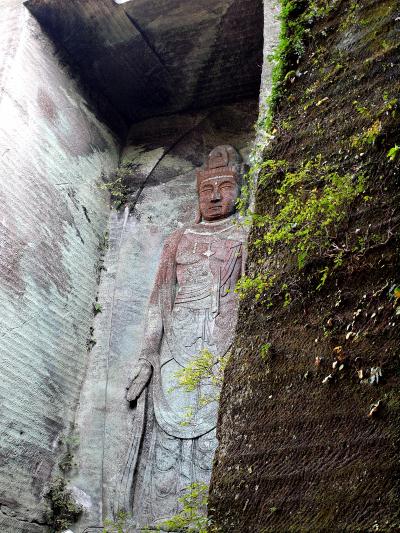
26;0;263;135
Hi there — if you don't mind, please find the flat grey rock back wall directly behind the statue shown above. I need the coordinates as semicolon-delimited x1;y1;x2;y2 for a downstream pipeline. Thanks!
71;101;258;531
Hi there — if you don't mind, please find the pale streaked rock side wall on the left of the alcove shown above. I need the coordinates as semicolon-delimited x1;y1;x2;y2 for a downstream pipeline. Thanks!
0;0;118;533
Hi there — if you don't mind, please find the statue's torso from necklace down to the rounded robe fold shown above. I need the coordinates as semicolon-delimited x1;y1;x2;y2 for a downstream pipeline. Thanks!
155;216;244;438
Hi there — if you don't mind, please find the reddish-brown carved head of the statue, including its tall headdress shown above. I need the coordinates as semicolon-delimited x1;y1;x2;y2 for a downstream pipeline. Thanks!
197;145;241;222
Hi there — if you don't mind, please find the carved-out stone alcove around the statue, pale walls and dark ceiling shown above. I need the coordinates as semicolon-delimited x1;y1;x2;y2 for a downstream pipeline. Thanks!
0;0;277;532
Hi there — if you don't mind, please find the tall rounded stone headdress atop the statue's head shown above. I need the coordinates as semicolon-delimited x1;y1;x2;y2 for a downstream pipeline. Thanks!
196;144;241;188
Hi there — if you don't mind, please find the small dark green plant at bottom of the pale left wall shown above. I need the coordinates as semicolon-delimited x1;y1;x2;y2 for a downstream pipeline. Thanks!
46;477;83;533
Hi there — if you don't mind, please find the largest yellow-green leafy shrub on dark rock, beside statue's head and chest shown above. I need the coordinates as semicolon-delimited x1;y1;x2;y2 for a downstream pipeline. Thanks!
236;155;368;305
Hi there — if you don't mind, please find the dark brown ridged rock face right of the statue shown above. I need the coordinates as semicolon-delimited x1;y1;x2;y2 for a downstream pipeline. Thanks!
210;0;400;533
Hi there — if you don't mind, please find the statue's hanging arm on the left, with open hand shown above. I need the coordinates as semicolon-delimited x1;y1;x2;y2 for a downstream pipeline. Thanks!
126;232;181;402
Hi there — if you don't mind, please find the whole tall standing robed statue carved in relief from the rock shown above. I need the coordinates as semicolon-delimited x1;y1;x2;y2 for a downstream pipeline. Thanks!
114;145;246;527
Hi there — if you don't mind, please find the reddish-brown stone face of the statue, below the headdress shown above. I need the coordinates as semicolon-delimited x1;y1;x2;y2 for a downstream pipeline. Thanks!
199;178;239;221
